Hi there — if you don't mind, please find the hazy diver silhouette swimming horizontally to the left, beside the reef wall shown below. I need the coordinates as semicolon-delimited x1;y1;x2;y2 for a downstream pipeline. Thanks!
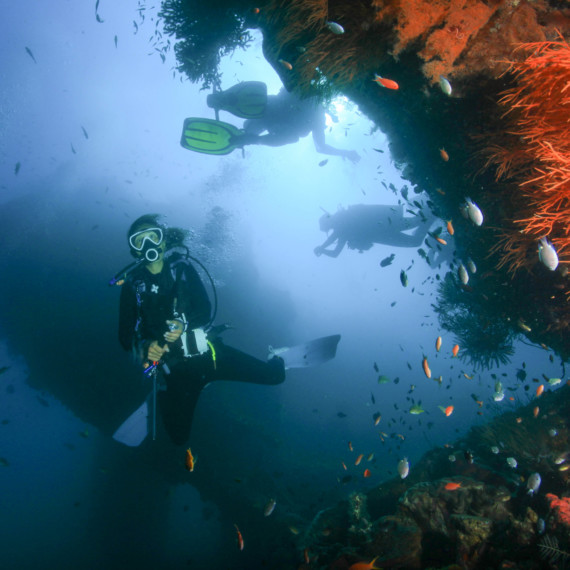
314;204;433;257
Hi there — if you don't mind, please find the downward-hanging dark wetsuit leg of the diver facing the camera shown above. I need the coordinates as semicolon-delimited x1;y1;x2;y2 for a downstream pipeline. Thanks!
158;358;206;445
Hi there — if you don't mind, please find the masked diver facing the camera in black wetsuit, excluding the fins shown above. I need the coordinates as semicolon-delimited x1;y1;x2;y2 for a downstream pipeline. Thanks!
119;214;285;445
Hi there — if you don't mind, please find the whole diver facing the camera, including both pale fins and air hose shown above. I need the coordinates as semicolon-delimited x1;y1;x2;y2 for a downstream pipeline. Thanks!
109;214;340;447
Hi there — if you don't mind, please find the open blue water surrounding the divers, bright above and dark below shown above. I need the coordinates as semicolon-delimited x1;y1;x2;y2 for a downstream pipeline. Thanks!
0;0;561;569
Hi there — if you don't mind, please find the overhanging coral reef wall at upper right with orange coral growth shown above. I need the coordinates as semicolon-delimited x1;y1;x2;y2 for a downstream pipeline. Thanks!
159;0;570;358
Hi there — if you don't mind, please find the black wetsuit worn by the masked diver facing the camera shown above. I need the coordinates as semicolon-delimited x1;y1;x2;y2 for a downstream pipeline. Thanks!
119;254;285;445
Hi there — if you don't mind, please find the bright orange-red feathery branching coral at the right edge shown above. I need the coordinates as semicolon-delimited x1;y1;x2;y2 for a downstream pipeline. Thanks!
487;37;570;272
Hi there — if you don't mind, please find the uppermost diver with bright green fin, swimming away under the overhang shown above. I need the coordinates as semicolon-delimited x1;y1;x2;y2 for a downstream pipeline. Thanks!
181;81;360;163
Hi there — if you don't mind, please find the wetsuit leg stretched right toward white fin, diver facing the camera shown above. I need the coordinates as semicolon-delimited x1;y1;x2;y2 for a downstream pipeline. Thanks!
207;341;285;385
